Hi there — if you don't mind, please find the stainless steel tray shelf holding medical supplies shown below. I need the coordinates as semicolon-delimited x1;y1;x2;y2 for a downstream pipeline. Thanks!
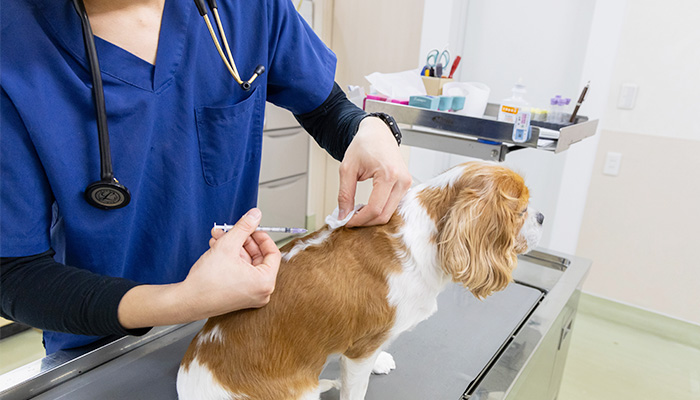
365;100;598;161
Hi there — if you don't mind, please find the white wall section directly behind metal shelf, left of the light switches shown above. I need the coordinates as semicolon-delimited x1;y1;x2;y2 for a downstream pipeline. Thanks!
416;0;621;253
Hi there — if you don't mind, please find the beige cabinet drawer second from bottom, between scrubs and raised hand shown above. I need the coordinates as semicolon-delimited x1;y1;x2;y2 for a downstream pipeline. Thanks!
260;128;309;183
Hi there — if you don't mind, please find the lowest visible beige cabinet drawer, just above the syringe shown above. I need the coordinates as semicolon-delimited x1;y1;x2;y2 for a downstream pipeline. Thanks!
258;174;307;241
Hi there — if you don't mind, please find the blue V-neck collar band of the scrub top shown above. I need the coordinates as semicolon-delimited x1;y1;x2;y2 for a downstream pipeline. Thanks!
37;0;194;92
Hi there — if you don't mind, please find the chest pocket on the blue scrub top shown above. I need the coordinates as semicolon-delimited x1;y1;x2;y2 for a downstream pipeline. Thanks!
195;89;264;186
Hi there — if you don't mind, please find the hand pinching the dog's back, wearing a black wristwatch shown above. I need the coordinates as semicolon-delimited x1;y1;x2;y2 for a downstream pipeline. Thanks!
338;117;411;227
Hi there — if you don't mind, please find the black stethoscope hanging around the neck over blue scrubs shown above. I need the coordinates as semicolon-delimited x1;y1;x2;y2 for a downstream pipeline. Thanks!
73;0;265;210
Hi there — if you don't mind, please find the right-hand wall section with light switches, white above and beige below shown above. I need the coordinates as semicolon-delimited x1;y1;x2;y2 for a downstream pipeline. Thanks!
577;0;700;323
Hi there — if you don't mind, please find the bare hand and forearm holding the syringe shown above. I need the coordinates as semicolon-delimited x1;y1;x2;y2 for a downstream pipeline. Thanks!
118;208;281;329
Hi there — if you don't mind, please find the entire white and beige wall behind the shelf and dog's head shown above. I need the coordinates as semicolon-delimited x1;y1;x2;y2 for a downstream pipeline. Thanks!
410;0;700;323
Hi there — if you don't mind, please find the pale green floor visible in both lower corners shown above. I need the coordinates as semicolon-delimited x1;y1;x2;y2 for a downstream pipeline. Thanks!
0;295;700;400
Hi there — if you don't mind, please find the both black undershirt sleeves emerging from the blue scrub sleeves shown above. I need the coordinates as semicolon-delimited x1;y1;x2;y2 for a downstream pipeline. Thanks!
0;80;367;336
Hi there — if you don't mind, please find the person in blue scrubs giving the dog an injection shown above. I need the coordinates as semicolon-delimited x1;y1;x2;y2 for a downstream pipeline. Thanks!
0;0;410;354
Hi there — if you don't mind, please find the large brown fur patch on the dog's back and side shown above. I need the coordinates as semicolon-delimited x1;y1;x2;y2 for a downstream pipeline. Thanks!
182;214;403;400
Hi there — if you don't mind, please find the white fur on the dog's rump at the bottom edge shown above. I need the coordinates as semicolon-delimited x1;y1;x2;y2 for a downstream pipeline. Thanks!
177;357;249;400
